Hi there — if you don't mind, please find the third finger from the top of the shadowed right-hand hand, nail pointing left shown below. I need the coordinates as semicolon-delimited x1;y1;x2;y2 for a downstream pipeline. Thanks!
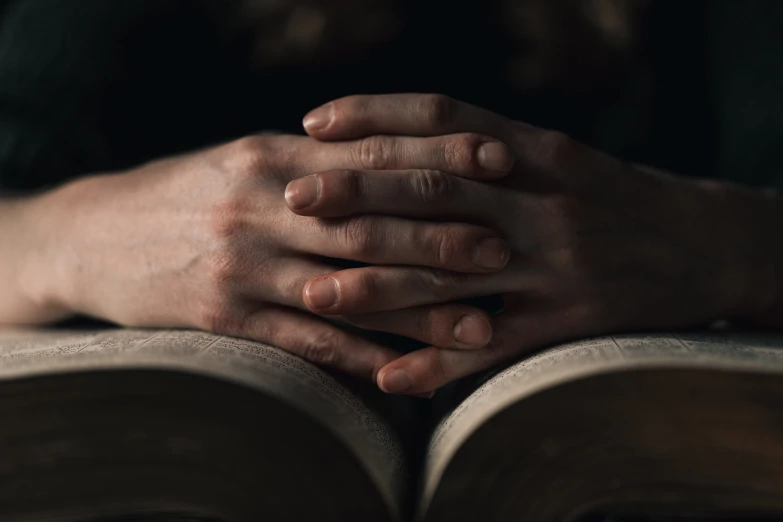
304;264;516;315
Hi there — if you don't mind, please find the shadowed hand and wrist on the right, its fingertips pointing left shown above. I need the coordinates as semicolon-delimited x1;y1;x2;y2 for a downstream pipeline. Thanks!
295;95;783;394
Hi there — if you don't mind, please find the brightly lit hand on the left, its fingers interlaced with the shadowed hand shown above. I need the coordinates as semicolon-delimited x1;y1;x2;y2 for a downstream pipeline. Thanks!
27;131;510;377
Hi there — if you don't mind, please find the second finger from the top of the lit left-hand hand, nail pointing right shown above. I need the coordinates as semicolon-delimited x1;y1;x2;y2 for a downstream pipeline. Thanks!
285;215;509;273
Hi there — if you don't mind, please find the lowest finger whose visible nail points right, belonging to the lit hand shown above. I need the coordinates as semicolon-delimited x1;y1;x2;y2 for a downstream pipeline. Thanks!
341;303;492;350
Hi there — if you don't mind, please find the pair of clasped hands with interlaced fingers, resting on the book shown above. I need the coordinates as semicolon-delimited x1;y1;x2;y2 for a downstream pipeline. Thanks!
49;95;774;394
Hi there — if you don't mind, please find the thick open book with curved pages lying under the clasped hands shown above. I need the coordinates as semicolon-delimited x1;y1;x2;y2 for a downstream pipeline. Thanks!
0;330;783;522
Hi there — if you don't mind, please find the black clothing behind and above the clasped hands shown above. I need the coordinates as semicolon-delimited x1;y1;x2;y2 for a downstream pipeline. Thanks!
0;0;783;191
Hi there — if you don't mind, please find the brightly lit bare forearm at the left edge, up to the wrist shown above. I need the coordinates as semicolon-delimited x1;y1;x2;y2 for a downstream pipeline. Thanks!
0;191;73;325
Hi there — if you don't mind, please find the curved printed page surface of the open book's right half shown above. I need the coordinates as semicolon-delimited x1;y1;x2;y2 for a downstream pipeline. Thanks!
422;332;783;505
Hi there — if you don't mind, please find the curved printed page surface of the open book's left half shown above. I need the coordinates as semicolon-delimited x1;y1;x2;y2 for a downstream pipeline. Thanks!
0;329;404;512
